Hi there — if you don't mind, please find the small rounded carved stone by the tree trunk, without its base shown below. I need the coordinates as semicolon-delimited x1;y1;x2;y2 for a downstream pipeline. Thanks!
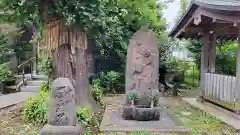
49;78;76;126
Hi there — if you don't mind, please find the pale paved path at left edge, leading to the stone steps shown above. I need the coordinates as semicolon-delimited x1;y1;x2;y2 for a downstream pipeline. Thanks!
0;92;36;109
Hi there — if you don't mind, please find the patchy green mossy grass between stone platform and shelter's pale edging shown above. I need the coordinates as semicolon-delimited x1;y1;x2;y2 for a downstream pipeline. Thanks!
164;99;235;135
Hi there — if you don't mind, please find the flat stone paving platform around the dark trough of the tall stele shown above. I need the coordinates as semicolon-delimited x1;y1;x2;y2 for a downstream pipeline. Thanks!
100;106;190;133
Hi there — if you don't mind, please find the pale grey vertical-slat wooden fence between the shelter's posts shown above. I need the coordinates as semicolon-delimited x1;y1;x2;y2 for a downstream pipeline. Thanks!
204;73;237;109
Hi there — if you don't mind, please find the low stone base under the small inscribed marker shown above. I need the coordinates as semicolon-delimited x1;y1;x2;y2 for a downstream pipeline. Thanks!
40;124;84;135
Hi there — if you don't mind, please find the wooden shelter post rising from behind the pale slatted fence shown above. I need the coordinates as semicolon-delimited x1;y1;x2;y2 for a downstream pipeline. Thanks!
209;33;216;73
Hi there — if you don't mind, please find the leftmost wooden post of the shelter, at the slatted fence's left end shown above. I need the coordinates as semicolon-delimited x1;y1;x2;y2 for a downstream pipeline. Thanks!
200;34;209;99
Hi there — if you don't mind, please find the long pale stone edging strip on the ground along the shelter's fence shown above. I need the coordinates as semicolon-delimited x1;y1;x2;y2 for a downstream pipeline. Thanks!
182;98;240;130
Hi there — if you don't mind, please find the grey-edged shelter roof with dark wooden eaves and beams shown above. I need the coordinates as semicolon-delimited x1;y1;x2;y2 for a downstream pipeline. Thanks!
169;0;240;40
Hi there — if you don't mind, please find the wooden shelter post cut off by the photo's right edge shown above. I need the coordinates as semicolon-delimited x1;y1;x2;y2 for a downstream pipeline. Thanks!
234;28;240;115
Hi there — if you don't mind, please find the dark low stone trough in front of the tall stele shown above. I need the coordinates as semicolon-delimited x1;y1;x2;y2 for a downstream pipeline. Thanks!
122;105;161;121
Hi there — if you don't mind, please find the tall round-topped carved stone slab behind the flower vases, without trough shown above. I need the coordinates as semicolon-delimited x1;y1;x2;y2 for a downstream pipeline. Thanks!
125;26;159;105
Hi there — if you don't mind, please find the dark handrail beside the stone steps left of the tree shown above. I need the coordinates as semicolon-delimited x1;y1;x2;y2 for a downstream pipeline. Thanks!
17;57;36;85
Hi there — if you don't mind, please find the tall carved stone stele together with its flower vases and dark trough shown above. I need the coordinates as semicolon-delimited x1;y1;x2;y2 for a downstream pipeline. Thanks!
123;28;160;121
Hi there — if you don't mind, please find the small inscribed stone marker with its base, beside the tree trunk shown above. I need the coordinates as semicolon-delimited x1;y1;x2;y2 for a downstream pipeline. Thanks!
40;78;84;135
